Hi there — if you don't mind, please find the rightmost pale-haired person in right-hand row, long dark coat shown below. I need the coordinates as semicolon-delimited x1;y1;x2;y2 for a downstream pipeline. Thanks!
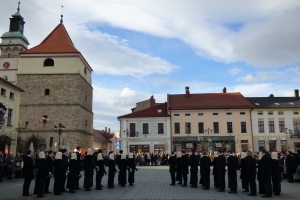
271;152;281;195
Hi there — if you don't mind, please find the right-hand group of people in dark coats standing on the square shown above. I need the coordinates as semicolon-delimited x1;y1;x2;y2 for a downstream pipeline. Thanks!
168;149;300;198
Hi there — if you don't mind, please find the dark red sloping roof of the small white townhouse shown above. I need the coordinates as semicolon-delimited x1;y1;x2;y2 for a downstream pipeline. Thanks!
118;103;170;118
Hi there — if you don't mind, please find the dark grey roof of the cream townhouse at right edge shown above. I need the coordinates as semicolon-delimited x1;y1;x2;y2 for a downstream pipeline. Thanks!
246;97;300;108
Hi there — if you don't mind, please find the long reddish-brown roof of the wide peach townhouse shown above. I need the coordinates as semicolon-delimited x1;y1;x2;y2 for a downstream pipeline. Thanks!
168;92;254;110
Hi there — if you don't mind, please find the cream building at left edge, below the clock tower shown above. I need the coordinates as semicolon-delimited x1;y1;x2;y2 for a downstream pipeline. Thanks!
0;78;26;154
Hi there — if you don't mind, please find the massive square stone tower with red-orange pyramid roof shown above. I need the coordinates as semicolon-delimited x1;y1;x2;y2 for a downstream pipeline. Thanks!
17;20;93;150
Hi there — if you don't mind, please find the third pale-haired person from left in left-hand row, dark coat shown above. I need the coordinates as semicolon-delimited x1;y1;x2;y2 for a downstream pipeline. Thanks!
67;153;79;193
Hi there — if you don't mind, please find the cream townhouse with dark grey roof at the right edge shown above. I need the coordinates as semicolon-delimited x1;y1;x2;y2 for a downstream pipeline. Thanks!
247;90;300;151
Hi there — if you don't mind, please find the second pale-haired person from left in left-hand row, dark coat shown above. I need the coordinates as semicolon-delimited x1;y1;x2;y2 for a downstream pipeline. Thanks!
53;152;64;195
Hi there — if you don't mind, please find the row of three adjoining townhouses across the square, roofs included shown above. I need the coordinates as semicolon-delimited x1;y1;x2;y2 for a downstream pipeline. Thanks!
118;87;300;152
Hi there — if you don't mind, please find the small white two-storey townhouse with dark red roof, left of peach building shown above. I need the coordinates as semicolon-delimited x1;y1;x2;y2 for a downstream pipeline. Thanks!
118;100;171;153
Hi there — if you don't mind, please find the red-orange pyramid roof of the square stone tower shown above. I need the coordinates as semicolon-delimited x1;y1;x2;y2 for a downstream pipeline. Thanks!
21;23;80;54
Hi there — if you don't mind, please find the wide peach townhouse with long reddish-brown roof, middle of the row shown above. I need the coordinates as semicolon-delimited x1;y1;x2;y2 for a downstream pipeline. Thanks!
168;87;253;152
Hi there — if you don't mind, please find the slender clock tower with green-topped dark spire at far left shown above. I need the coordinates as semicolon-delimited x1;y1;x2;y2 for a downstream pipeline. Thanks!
0;2;29;84
